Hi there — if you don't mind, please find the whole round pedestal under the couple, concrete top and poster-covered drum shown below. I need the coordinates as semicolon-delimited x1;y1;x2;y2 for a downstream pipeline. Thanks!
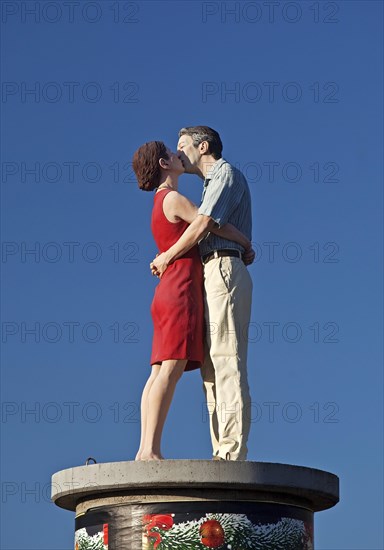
52;460;339;550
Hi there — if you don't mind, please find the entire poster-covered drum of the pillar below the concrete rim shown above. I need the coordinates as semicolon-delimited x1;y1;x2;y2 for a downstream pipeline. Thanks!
75;504;313;550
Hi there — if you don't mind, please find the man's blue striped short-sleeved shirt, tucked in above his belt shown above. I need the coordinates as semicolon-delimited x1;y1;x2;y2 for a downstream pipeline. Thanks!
198;158;252;256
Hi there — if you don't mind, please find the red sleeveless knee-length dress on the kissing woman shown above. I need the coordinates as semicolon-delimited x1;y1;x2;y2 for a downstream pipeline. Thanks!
151;190;204;370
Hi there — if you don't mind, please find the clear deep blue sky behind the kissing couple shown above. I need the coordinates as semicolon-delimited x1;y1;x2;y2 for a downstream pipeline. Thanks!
1;0;384;550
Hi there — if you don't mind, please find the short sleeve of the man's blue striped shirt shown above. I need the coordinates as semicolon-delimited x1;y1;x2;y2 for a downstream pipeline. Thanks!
198;166;244;227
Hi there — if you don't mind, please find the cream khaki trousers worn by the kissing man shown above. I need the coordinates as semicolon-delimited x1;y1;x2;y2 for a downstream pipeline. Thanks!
201;257;253;460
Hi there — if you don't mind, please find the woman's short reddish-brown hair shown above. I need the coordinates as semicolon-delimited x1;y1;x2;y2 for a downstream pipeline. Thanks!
132;141;169;191
